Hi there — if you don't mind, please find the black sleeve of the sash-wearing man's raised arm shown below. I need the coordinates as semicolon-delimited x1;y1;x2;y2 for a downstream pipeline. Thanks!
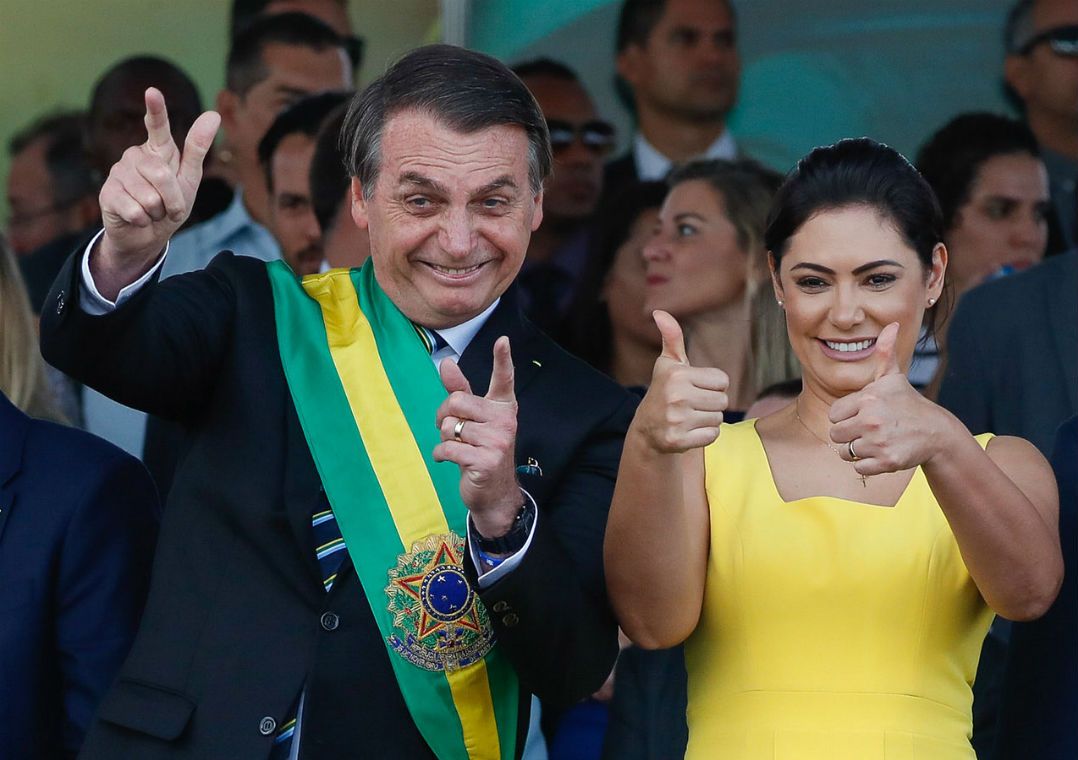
41;244;235;418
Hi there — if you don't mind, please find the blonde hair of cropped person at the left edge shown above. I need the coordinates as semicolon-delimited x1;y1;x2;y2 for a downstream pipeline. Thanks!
0;236;66;422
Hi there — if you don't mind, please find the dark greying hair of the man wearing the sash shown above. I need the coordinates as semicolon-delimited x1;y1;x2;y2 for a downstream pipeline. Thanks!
341;45;553;198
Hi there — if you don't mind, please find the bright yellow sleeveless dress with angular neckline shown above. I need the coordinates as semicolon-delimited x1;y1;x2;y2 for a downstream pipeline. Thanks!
686;419;992;760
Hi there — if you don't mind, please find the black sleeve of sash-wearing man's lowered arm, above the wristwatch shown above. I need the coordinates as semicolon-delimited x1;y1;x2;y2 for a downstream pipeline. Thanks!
481;393;636;705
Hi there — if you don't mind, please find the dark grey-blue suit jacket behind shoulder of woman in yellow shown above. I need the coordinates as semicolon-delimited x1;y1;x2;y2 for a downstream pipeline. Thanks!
939;251;1078;456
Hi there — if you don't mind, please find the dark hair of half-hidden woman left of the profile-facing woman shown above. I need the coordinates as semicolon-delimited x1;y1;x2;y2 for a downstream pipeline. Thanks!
558;182;667;373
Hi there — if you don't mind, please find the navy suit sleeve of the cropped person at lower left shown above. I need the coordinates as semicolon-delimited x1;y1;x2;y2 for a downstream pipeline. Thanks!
55;456;158;757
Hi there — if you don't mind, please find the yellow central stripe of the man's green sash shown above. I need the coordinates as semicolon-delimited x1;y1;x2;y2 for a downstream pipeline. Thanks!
303;270;501;760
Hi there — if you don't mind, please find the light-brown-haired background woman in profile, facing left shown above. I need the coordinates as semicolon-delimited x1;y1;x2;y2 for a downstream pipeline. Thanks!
644;161;780;411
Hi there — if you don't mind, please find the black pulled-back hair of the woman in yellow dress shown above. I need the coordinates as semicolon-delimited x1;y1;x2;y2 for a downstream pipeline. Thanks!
763;137;943;334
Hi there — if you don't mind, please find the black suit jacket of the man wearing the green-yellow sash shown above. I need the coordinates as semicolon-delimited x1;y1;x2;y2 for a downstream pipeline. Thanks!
42;253;634;760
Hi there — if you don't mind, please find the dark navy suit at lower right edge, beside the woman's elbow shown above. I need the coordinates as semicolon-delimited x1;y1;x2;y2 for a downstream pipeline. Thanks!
993;416;1078;760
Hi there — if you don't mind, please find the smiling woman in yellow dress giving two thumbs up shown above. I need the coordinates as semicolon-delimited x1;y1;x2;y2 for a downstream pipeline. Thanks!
605;139;1062;760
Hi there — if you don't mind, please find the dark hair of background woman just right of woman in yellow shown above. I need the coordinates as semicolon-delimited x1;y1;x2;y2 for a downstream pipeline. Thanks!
917;112;1040;231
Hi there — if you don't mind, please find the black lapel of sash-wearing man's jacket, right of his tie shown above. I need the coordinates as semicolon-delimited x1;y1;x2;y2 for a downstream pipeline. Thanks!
459;286;542;398
